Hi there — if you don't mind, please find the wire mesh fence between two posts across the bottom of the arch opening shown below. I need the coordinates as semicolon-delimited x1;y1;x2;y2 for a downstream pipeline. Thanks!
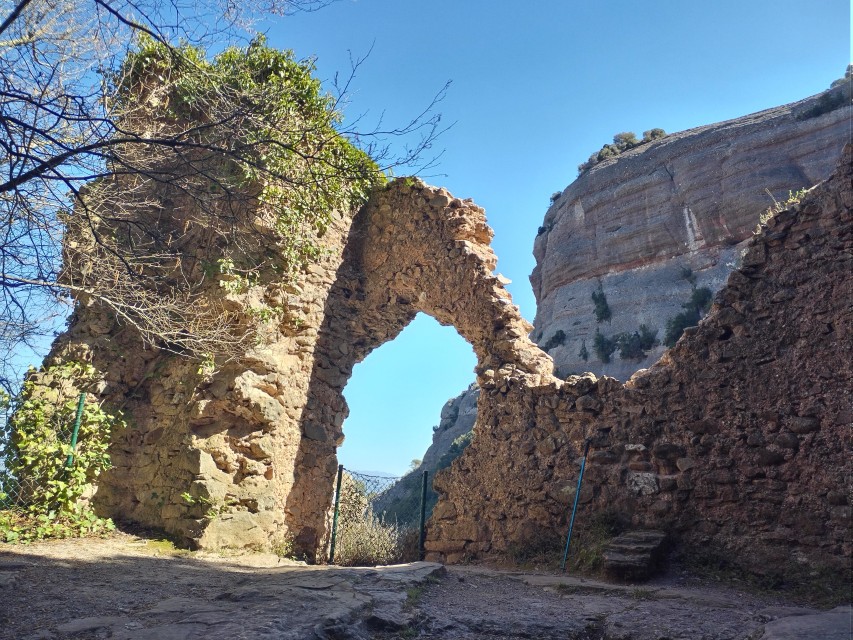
329;466;432;566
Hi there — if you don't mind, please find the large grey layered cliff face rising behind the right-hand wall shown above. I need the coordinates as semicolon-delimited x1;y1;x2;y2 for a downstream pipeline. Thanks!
530;83;853;380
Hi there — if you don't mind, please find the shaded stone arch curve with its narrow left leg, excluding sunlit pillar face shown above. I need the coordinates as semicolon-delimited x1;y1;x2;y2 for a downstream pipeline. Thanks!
285;180;553;549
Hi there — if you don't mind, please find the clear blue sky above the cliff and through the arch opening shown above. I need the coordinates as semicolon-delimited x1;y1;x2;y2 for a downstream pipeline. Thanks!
264;0;853;473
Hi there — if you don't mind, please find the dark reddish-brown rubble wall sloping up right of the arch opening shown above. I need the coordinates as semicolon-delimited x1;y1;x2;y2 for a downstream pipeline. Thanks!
427;145;853;576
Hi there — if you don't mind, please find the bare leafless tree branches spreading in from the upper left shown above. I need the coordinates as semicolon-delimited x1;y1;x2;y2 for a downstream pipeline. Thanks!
0;0;450;391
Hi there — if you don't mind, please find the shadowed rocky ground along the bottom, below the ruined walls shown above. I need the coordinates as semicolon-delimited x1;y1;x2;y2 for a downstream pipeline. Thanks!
0;534;853;640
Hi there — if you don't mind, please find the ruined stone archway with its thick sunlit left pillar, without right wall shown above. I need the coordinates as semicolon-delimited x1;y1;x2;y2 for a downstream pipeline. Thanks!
45;179;552;554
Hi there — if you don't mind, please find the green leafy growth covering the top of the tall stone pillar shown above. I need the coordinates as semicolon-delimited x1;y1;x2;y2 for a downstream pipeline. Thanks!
112;36;384;280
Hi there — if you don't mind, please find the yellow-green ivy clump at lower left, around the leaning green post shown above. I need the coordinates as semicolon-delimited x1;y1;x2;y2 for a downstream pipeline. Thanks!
0;362;123;542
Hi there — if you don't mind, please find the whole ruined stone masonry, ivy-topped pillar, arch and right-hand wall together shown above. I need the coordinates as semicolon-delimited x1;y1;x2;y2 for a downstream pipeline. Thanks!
30;119;853;592
